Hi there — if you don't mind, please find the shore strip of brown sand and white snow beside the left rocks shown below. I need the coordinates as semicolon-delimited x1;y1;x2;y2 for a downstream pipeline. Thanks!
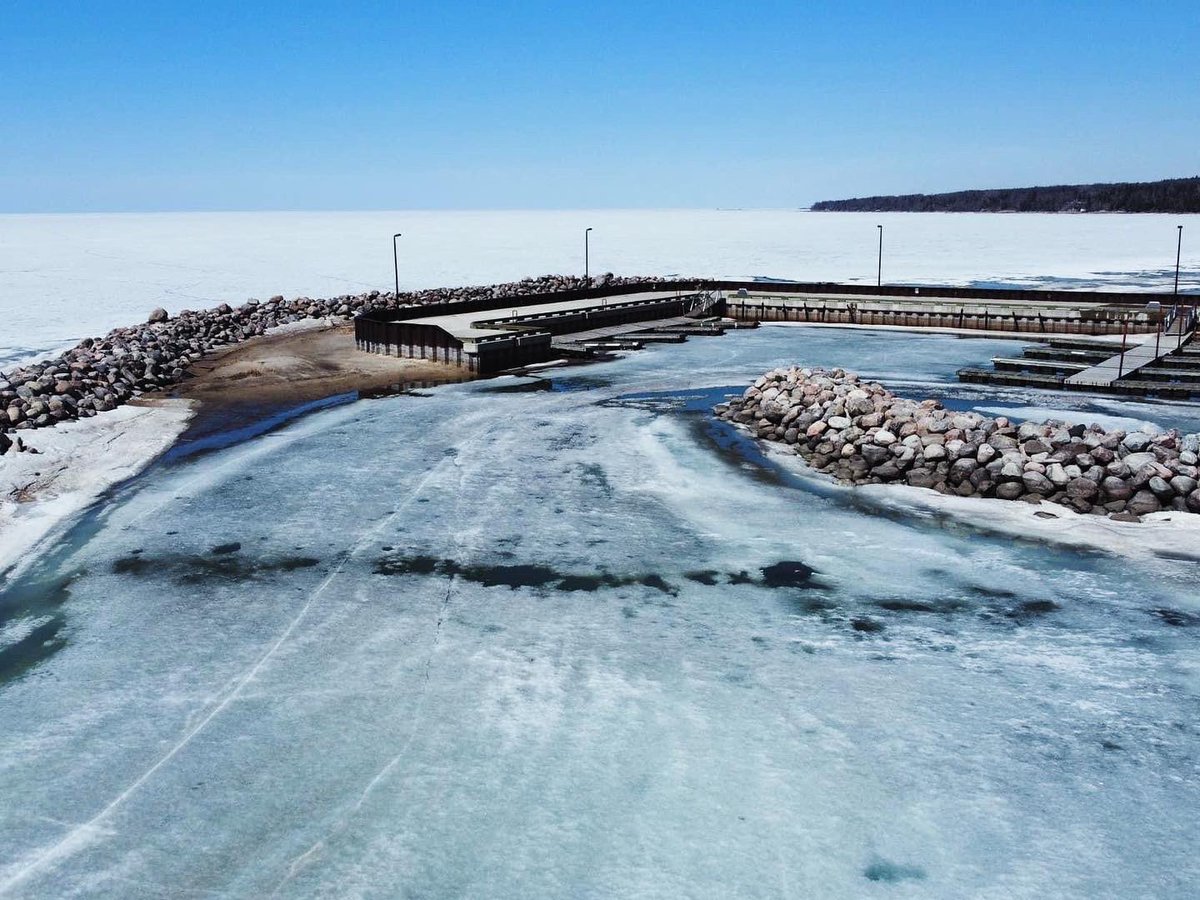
0;320;468;586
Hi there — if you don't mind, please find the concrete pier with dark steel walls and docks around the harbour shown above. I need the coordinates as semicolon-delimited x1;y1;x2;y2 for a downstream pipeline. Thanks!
355;280;1195;392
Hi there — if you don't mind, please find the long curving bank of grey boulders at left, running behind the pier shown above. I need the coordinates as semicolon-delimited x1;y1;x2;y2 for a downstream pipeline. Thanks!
0;272;659;455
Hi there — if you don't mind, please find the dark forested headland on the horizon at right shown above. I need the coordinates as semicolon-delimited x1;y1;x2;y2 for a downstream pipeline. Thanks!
812;176;1200;212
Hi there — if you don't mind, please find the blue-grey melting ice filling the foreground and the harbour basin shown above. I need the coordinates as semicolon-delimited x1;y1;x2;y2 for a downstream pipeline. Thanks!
0;326;1200;899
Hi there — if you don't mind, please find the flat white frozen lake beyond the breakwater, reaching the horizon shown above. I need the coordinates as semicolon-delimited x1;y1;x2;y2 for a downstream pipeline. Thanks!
0;210;1200;370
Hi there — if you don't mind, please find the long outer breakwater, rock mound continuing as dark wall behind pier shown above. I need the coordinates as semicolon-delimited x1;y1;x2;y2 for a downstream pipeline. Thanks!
0;267;1166;454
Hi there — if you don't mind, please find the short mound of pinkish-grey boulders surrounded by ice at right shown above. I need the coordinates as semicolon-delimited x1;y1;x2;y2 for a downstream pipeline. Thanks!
714;367;1200;521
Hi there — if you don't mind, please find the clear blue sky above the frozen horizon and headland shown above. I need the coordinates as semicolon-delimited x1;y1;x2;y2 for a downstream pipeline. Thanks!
0;0;1200;212
